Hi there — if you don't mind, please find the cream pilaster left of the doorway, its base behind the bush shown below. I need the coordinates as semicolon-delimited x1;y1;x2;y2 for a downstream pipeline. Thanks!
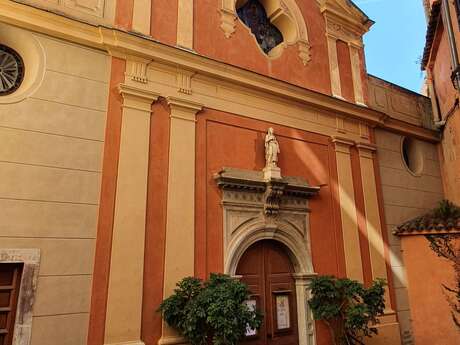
159;97;202;344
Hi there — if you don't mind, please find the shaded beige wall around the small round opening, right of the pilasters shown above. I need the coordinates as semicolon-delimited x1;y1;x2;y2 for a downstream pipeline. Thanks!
376;130;443;344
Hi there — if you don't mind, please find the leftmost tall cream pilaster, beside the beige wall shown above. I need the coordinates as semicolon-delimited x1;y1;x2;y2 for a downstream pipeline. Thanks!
104;84;158;345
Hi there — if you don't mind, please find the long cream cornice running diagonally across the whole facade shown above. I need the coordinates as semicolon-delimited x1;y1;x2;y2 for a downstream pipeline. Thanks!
0;0;439;141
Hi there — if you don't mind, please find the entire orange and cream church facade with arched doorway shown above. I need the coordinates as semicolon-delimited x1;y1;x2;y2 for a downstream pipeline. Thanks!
0;0;444;345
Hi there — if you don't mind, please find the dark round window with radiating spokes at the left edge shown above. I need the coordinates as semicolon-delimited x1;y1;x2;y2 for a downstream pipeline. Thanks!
0;44;24;96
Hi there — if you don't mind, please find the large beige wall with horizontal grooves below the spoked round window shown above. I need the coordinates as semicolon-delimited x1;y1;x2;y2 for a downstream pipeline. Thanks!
0;27;109;345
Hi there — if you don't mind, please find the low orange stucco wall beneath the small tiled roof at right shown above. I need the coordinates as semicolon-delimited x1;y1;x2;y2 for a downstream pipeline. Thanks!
402;236;460;345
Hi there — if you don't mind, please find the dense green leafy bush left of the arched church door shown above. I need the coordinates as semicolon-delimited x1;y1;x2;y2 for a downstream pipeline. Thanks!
159;274;262;345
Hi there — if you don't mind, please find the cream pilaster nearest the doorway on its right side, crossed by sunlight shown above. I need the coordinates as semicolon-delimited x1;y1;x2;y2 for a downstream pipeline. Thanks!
333;137;364;282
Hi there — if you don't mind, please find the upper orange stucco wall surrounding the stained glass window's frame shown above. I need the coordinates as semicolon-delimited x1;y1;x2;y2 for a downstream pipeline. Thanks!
194;0;331;94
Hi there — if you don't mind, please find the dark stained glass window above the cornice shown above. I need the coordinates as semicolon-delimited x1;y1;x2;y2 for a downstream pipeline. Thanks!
237;0;283;54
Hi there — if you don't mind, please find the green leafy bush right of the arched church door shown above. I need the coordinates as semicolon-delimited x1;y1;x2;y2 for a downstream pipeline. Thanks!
308;276;386;345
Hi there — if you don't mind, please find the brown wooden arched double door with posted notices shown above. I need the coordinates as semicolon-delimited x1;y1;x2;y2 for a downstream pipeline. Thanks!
236;240;299;345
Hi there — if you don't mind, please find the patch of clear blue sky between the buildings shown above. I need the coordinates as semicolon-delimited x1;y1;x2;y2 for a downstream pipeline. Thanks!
354;0;426;92
